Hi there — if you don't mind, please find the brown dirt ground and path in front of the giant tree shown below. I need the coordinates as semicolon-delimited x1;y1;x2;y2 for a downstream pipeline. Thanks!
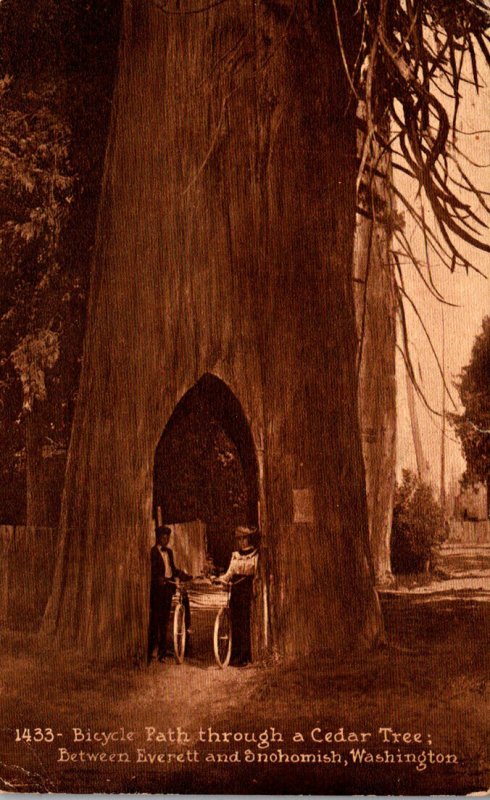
0;546;490;794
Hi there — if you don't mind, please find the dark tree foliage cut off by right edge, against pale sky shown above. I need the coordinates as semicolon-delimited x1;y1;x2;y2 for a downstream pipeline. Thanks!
450;316;490;485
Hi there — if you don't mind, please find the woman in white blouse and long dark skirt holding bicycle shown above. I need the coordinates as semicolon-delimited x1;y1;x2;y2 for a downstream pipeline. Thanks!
220;525;258;667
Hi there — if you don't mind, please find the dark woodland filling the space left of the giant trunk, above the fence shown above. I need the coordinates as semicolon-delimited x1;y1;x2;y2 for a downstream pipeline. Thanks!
0;0;121;525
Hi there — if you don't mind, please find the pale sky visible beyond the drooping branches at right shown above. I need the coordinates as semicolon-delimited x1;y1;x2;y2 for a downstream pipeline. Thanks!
397;75;490;500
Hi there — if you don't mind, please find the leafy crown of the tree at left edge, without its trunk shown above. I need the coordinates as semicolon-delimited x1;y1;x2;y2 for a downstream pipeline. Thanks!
0;76;75;410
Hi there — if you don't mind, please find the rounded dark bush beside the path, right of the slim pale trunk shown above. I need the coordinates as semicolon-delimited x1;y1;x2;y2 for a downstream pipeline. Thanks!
391;470;445;574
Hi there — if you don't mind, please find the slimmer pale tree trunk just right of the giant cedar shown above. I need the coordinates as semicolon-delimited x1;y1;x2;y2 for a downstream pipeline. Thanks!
354;129;396;585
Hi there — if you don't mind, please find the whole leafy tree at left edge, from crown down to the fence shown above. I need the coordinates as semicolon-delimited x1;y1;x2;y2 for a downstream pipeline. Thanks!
0;76;75;522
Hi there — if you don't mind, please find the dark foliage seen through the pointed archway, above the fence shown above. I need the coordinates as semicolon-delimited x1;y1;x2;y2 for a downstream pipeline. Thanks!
153;373;259;568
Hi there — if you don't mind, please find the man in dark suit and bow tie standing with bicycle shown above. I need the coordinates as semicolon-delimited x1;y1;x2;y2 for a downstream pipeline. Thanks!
148;525;191;663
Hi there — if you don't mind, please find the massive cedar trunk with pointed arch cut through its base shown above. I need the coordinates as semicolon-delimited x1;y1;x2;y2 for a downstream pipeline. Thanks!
45;0;382;658
